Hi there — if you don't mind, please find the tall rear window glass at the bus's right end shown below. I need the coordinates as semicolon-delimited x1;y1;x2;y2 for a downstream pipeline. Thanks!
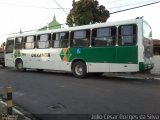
143;22;153;58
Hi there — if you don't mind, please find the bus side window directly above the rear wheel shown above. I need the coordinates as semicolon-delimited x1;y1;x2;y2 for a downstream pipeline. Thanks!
71;30;90;47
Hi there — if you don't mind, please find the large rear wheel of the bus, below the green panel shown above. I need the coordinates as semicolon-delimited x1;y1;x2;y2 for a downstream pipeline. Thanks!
72;61;87;78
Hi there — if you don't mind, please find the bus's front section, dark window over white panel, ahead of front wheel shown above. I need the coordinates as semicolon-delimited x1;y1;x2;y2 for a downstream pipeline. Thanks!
5;39;15;67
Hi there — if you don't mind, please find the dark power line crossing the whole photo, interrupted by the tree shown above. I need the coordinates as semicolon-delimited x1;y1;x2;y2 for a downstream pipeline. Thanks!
0;1;160;36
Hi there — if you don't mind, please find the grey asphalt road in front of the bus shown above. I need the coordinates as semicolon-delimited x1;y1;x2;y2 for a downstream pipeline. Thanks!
0;67;160;119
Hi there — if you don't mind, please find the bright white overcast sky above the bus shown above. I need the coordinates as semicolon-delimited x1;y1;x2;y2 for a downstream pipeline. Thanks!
0;0;160;44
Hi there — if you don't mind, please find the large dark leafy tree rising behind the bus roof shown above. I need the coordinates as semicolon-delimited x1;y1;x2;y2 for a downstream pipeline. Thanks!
67;0;110;26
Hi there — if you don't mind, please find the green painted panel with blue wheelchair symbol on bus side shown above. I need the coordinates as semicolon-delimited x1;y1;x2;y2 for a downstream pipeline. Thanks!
66;46;138;64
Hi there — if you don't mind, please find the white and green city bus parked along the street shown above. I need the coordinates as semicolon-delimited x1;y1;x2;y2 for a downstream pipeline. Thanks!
5;19;153;78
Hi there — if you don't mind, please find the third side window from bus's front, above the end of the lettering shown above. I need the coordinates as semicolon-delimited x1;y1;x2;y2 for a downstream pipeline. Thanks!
37;34;51;49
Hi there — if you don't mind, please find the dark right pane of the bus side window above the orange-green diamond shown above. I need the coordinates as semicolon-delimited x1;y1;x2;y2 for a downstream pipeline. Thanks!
59;32;69;48
